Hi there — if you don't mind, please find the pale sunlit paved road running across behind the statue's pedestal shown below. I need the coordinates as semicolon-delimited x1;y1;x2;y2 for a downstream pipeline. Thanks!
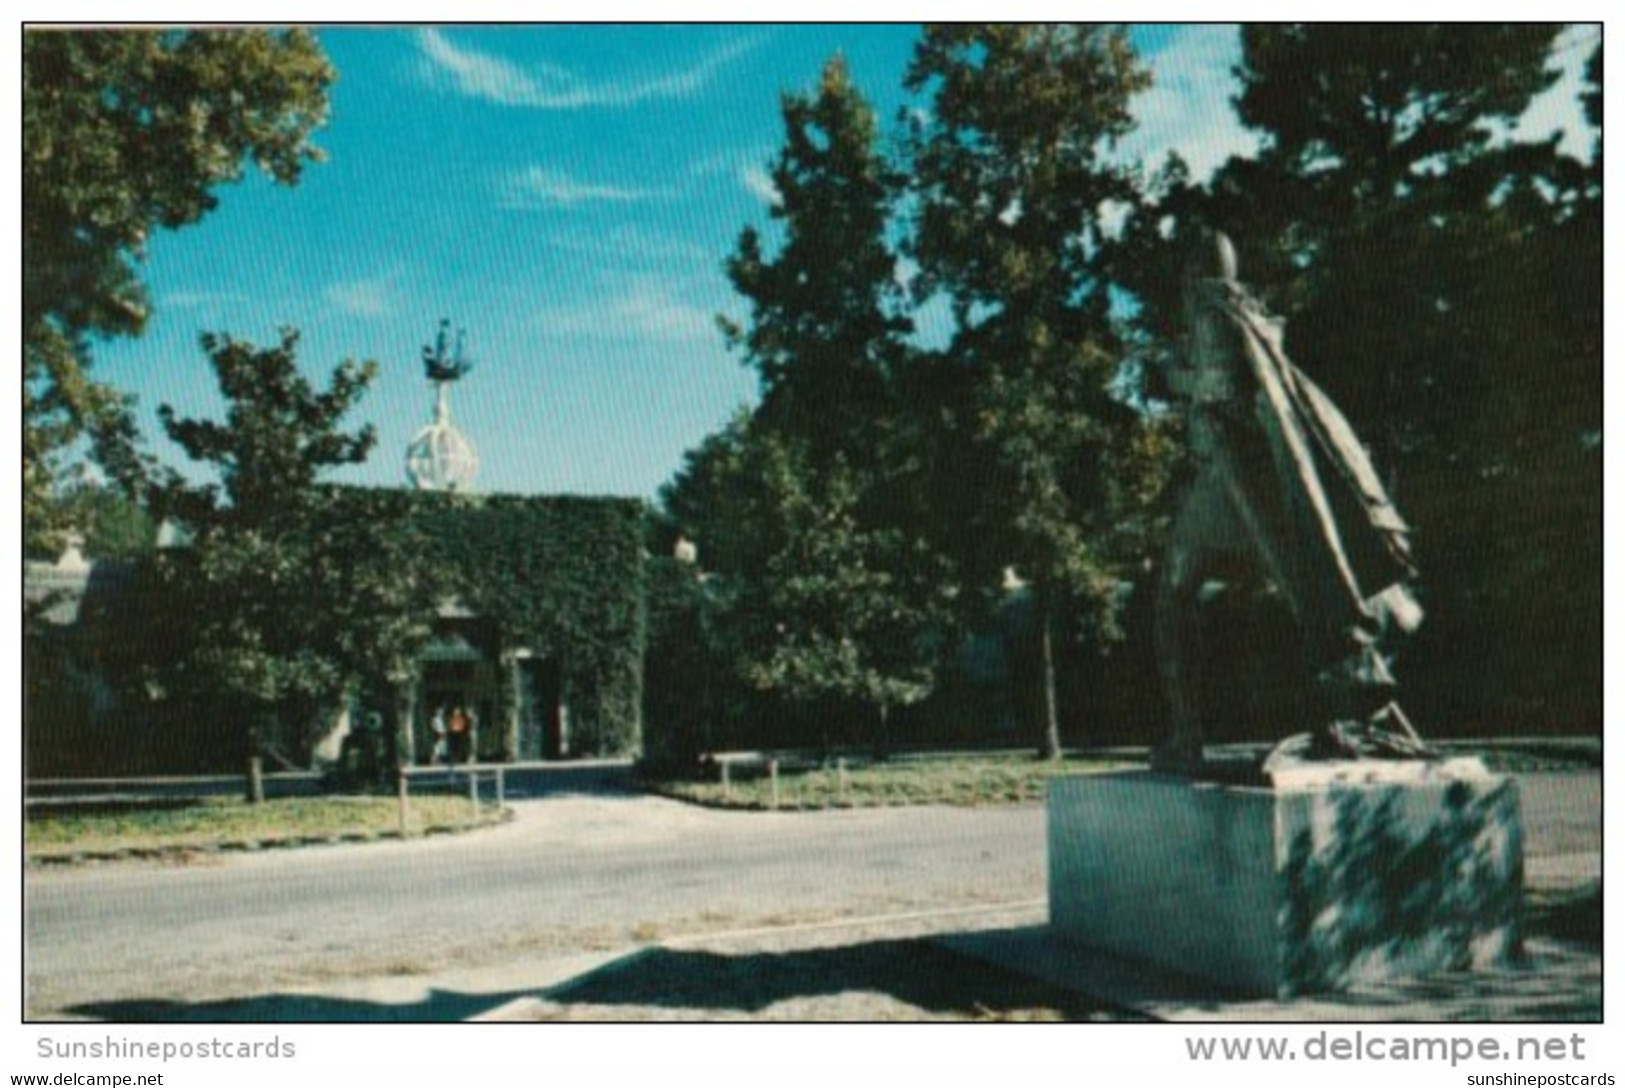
24;775;1601;1017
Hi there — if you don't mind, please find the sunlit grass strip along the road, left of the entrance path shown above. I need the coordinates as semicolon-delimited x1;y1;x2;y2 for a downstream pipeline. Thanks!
23;796;502;861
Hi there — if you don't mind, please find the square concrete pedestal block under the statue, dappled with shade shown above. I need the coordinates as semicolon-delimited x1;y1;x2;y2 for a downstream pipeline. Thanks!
1048;768;1523;997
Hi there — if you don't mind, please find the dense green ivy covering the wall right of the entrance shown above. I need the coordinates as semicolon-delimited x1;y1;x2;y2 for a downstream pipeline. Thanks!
413;492;645;755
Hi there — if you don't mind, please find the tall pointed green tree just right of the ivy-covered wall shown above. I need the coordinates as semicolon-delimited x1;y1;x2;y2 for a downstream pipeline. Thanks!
666;57;946;745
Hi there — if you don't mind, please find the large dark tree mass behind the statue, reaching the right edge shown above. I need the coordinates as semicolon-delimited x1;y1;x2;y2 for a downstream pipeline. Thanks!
1118;24;1602;729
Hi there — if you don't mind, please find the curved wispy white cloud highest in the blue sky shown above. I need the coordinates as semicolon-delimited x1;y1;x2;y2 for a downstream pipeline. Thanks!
418;28;756;110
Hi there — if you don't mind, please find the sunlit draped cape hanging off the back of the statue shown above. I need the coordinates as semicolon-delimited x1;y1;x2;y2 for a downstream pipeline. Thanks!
1225;296;1420;625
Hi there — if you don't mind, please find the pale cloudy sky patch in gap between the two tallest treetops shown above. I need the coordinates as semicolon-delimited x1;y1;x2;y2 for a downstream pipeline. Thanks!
1120;24;1258;182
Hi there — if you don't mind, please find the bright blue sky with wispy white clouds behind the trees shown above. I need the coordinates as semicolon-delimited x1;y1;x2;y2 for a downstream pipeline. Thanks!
96;24;1586;497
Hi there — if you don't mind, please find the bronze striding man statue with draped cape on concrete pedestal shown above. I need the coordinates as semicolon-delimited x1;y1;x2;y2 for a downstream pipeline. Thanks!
1152;234;1427;775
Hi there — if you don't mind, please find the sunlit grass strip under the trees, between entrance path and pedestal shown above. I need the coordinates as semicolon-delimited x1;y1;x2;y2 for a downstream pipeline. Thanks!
645;753;1133;809
